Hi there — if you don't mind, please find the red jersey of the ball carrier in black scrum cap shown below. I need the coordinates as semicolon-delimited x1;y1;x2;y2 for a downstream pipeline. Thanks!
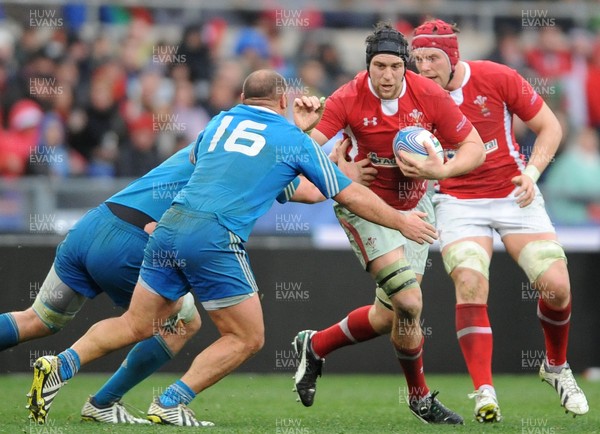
316;71;472;210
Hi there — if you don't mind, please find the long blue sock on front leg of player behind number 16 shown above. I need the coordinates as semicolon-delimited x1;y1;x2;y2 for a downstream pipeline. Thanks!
94;335;173;406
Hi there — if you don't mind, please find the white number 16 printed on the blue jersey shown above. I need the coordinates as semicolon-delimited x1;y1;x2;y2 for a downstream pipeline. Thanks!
208;116;267;157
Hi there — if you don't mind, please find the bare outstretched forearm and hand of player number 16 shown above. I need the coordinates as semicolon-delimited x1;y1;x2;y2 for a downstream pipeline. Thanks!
333;182;437;244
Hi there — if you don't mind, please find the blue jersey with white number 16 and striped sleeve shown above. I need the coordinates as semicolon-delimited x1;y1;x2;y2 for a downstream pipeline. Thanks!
174;104;351;240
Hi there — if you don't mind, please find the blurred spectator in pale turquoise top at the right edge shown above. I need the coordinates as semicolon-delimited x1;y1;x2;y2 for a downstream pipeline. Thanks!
544;128;600;225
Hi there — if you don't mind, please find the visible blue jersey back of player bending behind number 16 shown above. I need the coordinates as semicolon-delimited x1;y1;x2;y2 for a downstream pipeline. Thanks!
106;143;194;221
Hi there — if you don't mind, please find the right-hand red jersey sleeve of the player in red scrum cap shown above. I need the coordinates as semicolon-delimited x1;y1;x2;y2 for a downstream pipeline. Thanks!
498;65;544;122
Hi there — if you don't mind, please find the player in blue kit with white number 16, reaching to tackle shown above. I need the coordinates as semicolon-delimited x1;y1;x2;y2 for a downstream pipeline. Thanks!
29;70;437;426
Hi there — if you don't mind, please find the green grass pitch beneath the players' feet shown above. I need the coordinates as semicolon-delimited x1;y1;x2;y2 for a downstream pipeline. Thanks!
0;373;600;434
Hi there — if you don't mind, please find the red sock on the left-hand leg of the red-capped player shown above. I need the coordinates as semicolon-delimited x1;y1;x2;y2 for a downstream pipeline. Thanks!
456;303;494;390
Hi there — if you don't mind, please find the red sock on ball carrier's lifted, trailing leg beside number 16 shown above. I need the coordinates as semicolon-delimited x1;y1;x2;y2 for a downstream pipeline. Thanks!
311;305;379;358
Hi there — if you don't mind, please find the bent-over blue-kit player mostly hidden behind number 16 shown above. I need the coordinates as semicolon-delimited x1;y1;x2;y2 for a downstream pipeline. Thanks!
0;145;321;424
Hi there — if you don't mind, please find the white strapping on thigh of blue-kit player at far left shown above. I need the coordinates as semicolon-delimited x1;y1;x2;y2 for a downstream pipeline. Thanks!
32;265;87;333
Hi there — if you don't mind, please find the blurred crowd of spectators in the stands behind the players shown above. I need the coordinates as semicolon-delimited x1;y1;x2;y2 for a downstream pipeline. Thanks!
0;1;600;231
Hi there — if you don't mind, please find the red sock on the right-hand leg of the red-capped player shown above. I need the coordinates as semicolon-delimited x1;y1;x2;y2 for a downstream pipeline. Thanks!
538;298;571;366
